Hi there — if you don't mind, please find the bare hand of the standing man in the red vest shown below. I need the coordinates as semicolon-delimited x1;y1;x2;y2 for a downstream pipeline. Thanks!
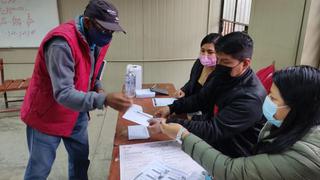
104;93;133;111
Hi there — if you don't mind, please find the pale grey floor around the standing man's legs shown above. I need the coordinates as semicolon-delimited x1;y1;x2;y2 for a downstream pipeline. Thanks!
0;102;118;180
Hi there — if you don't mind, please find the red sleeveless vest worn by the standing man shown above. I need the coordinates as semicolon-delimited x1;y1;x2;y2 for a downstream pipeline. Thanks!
20;21;109;137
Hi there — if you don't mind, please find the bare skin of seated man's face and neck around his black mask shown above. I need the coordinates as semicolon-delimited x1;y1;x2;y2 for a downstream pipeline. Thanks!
217;53;251;77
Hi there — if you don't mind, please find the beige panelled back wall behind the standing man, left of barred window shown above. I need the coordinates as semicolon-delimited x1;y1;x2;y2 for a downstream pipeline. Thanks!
0;0;220;91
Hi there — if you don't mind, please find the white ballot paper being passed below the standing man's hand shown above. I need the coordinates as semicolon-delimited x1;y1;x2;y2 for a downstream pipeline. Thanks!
122;104;153;126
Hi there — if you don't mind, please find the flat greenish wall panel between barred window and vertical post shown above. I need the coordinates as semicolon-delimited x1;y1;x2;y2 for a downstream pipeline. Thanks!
249;0;305;69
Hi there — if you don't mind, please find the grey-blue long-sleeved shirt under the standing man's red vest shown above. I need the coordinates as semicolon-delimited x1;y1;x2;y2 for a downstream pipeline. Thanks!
44;18;106;112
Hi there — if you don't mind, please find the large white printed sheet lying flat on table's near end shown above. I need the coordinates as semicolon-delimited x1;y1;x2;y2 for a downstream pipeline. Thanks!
120;141;205;180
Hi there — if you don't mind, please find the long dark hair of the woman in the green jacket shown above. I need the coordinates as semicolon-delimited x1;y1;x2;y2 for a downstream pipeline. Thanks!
256;66;320;154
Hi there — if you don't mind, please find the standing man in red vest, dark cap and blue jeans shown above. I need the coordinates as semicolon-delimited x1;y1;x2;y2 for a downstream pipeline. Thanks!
21;0;132;180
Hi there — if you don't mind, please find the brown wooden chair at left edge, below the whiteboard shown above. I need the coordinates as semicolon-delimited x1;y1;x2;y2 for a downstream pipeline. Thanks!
0;58;30;113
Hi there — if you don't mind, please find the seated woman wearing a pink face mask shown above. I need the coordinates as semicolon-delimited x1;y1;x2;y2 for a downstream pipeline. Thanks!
175;33;221;98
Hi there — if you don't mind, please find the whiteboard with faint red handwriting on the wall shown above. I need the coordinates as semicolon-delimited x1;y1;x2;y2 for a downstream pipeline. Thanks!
0;0;59;48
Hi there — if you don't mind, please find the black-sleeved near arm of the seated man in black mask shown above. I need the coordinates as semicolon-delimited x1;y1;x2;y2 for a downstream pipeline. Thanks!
168;96;262;143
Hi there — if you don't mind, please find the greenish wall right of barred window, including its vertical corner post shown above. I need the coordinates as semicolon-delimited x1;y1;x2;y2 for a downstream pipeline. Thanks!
249;0;320;69
